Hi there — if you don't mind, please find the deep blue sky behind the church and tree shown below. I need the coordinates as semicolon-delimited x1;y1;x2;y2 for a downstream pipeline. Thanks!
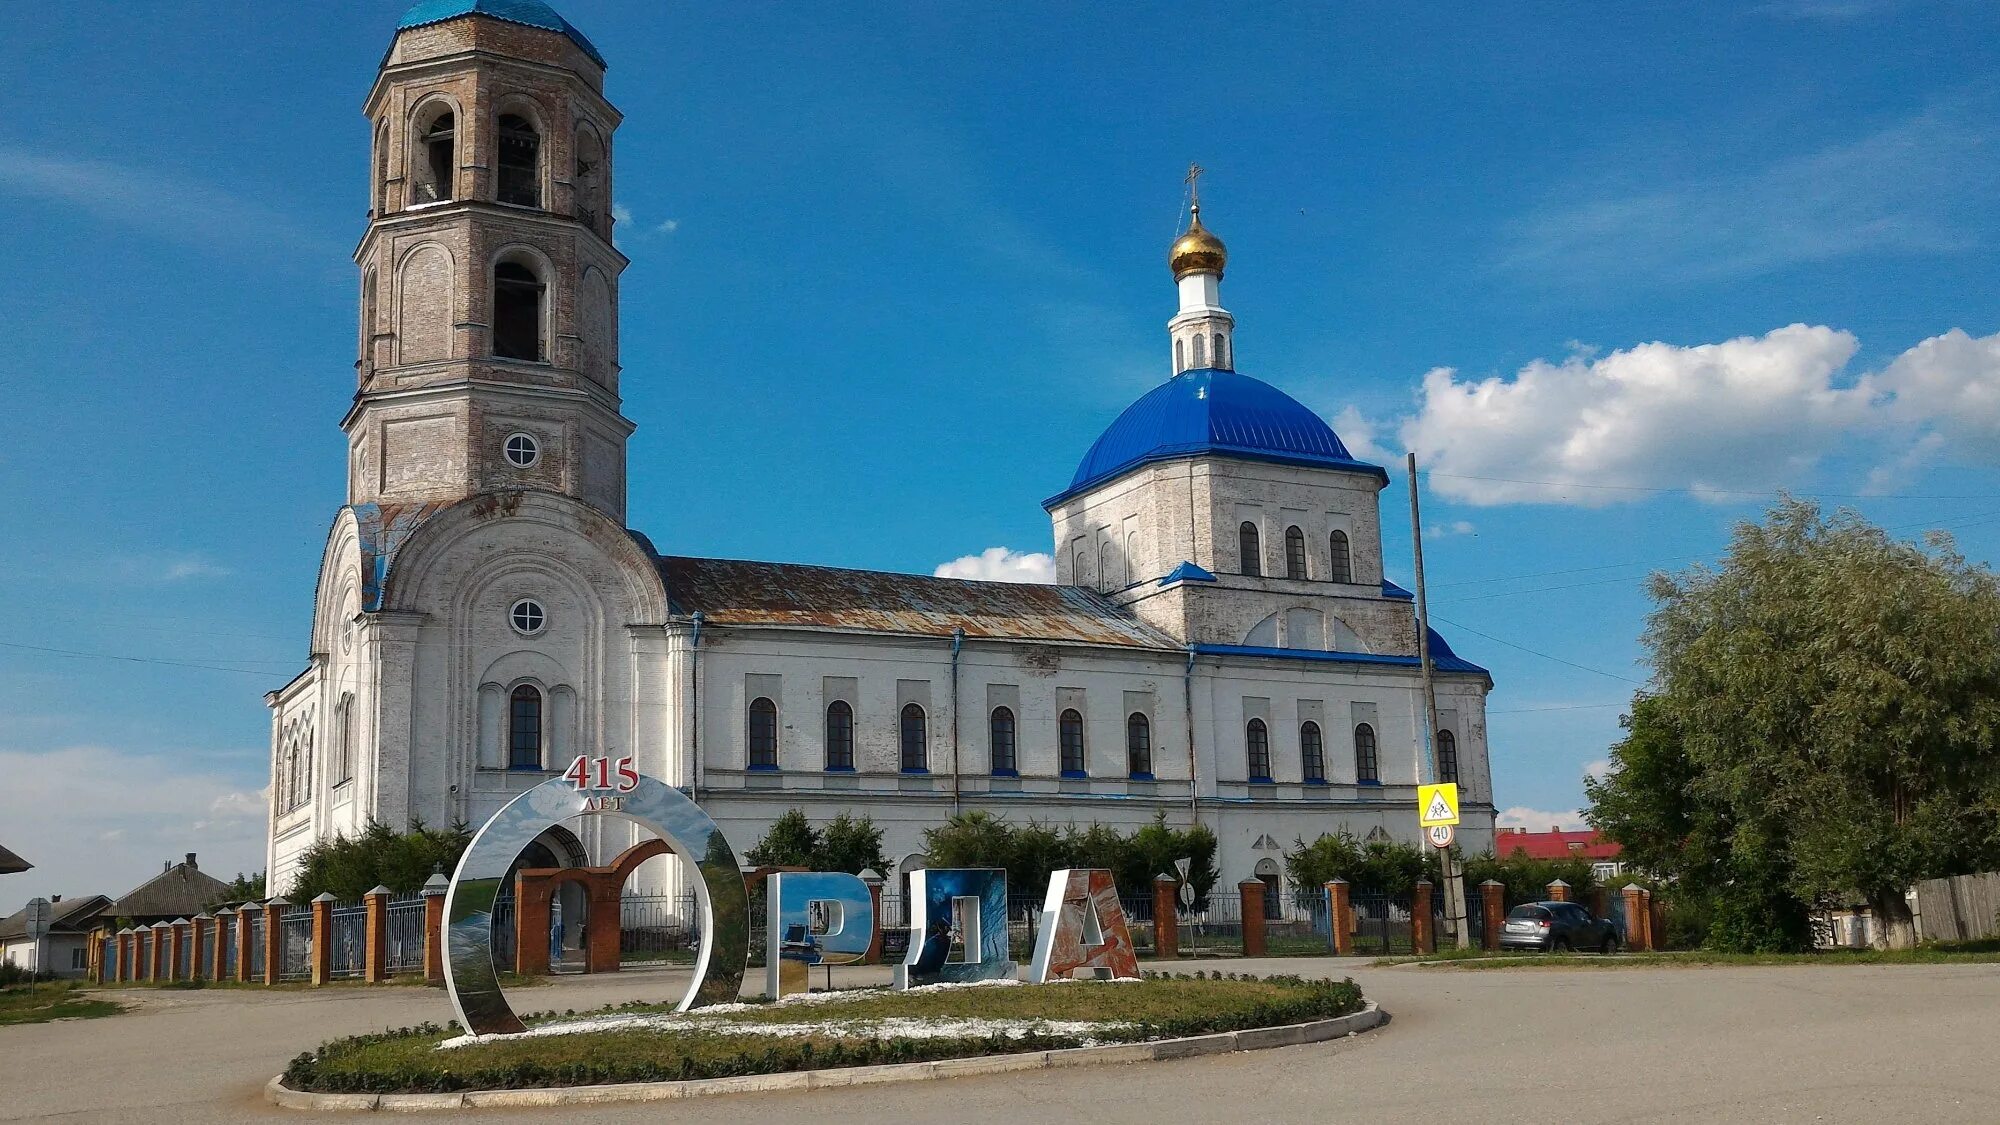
0;0;2000;909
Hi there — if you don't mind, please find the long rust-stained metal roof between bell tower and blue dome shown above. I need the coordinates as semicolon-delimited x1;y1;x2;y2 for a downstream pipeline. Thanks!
658;554;1180;651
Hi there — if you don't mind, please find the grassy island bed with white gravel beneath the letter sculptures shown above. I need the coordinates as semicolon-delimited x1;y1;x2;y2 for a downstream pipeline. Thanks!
286;975;1362;1093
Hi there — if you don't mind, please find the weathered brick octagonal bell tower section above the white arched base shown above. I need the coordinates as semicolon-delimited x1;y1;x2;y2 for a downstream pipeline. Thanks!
342;0;632;522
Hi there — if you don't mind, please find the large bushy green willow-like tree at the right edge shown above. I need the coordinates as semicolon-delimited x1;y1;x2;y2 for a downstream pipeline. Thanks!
1590;498;2000;945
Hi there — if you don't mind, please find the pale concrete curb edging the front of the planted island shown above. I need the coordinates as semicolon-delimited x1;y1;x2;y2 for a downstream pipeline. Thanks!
264;1001;1388;1113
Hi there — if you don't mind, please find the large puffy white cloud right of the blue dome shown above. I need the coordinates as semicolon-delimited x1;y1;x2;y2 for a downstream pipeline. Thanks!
1400;324;2000;506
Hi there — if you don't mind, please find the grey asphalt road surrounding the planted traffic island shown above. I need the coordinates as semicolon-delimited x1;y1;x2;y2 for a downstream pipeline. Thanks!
0;959;2000;1125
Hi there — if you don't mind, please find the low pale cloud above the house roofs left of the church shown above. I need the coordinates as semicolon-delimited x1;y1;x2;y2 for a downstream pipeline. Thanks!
0;747;266;913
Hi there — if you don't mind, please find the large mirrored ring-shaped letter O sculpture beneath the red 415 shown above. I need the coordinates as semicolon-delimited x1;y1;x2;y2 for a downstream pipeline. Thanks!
444;777;748;1035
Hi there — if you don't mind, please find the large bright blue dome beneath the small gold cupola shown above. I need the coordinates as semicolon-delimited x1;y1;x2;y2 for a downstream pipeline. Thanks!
1044;368;1388;508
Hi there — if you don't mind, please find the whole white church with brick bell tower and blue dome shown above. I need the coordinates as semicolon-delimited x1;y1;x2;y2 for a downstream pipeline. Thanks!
266;0;1494;891
